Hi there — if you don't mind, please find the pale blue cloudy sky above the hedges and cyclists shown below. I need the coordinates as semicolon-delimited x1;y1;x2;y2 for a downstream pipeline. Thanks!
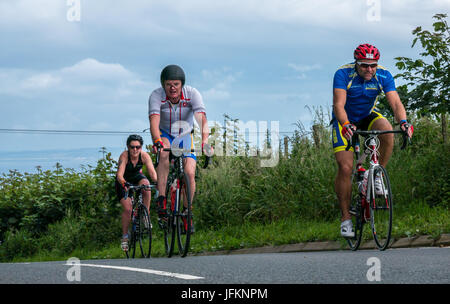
0;0;450;172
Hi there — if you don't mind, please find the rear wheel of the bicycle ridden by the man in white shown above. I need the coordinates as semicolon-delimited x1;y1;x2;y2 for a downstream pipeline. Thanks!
164;180;178;258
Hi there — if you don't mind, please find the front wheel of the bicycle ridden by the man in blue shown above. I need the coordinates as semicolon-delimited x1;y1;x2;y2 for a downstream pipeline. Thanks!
367;165;393;250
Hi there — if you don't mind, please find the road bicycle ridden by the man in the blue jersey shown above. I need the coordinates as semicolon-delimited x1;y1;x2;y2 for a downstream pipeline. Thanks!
346;130;408;251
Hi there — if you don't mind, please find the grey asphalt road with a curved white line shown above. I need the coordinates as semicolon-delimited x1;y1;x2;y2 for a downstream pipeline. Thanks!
0;247;450;288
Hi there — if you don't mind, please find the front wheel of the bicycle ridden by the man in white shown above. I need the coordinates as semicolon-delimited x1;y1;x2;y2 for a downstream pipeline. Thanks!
175;173;192;258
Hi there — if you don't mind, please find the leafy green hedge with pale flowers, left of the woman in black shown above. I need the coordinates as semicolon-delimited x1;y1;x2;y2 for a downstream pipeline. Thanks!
0;153;121;258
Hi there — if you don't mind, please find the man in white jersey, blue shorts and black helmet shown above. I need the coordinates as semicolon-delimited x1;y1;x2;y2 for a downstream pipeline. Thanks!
148;65;209;230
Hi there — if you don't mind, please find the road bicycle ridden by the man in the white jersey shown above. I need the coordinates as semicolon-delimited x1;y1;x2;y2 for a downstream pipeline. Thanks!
155;148;210;257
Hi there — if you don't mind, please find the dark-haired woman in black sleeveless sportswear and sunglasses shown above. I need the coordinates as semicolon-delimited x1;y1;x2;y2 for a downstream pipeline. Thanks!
116;134;157;251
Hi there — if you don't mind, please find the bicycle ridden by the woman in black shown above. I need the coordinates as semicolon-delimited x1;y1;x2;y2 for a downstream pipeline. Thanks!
125;183;156;258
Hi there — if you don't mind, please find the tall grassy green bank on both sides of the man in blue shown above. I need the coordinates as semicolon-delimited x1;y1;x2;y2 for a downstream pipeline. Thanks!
194;118;450;228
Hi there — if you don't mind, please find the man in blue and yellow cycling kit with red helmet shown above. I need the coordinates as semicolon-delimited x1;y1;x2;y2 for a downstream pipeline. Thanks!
332;44;414;237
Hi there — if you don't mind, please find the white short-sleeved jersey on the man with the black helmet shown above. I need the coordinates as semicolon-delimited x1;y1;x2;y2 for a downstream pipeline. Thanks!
148;85;206;137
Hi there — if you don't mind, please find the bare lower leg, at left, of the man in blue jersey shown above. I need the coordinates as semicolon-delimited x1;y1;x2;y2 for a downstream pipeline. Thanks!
334;151;353;221
